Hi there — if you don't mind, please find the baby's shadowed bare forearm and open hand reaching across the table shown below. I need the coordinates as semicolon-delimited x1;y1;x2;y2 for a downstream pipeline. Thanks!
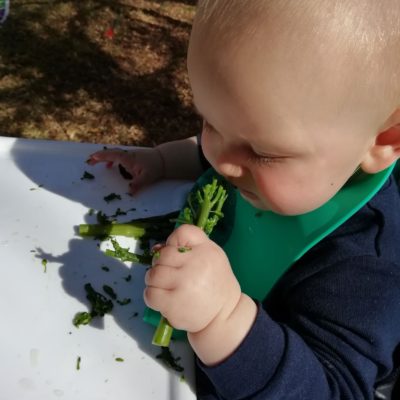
88;137;203;193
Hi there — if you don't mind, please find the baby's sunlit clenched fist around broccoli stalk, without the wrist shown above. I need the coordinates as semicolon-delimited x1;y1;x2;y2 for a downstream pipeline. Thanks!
144;225;241;333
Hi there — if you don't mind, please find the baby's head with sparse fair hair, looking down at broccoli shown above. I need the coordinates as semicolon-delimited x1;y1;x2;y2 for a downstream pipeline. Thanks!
188;0;400;214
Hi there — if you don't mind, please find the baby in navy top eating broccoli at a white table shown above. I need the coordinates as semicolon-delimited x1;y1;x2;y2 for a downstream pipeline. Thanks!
90;0;400;400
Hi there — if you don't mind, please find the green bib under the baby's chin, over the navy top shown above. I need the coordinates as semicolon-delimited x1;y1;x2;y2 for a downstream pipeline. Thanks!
144;164;395;334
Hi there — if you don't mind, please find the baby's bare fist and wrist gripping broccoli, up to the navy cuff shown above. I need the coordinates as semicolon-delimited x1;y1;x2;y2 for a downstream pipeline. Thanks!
144;225;257;365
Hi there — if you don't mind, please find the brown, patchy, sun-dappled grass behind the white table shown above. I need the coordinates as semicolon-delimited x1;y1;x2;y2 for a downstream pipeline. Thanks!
0;0;200;146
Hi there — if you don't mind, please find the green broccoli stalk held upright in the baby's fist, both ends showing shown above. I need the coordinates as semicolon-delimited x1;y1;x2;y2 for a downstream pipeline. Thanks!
152;178;228;347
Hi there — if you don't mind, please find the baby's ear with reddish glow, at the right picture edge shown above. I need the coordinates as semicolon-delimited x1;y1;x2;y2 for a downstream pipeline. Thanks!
360;108;400;174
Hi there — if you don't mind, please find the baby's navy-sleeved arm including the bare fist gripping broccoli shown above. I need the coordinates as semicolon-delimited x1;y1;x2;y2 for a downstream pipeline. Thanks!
144;219;400;400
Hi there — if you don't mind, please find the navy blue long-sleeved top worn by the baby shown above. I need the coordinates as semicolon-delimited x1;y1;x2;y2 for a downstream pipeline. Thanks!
197;177;400;400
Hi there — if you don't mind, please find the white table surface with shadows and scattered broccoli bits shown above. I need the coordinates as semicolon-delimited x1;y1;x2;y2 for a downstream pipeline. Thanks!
0;137;196;400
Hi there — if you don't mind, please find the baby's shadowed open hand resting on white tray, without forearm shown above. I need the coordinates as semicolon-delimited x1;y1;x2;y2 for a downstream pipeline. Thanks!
87;148;165;193
